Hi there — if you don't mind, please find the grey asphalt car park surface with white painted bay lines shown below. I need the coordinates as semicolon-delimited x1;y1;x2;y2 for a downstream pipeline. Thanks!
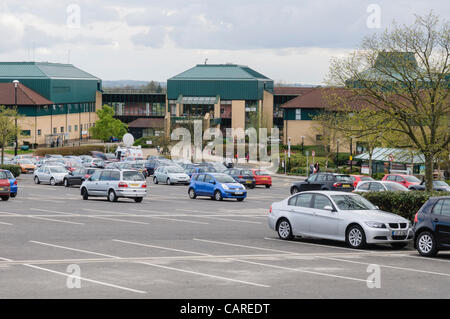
0;175;450;298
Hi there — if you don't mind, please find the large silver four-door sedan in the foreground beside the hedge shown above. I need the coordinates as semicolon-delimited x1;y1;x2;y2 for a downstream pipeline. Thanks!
268;191;414;249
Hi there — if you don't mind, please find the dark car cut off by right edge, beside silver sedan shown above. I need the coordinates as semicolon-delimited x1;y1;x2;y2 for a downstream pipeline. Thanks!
414;196;450;257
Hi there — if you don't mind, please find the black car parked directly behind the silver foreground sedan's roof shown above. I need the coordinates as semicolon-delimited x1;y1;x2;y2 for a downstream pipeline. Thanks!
291;173;354;194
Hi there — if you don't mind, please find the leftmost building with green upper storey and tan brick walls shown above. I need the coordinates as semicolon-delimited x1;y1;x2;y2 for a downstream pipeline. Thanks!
0;62;102;145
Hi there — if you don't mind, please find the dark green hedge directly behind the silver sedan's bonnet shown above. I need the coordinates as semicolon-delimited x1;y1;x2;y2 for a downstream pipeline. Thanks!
360;191;442;222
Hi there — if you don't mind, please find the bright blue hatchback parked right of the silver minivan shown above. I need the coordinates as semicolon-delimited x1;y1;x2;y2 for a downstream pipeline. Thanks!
188;173;247;202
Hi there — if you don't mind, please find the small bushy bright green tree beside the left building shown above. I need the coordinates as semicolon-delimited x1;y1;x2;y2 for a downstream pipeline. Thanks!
89;105;128;142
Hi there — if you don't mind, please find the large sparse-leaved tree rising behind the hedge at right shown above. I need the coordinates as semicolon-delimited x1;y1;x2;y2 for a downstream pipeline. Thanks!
328;13;450;191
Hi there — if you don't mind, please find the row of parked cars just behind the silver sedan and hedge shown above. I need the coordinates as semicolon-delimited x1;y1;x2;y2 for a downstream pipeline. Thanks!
290;173;450;194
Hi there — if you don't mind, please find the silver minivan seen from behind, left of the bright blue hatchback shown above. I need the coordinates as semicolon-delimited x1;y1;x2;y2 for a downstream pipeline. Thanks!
80;170;147;203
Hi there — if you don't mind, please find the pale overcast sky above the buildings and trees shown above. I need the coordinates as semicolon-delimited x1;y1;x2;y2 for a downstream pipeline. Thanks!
0;0;450;84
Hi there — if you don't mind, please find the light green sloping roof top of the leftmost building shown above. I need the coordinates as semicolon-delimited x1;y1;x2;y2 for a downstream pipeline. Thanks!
0;62;100;80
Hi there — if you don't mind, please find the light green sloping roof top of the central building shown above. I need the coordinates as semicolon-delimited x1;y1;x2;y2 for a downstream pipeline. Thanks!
169;64;270;80
